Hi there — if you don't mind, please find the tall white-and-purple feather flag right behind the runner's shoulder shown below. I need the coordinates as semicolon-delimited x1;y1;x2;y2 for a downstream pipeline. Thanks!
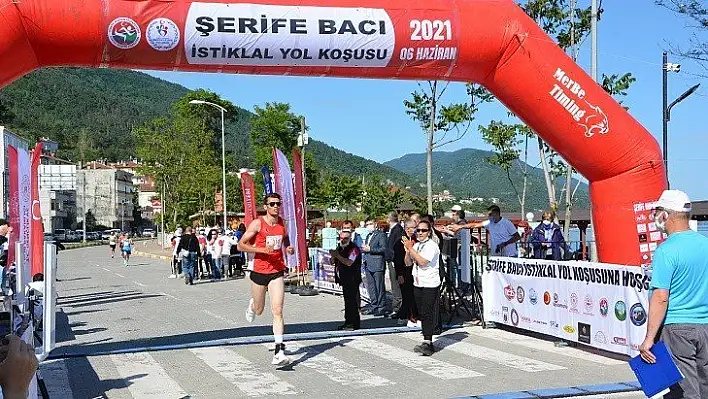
273;147;298;269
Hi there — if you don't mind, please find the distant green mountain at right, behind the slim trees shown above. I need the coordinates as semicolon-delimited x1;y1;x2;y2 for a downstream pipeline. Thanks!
384;148;589;210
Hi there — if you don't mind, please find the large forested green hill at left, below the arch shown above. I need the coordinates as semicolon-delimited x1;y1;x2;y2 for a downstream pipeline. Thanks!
0;68;415;186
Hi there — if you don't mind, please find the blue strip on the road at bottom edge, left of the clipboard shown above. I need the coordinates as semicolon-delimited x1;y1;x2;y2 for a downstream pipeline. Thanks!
457;381;642;399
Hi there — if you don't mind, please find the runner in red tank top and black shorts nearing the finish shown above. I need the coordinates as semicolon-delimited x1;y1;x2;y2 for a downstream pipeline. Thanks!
238;193;295;365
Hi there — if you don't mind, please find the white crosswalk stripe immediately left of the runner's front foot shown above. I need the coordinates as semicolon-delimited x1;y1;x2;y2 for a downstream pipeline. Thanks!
190;347;298;396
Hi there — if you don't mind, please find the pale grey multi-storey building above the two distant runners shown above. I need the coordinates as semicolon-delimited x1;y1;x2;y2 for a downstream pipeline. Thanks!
76;167;135;231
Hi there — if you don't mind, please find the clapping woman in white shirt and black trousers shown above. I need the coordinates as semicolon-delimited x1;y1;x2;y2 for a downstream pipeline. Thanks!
401;220;440;356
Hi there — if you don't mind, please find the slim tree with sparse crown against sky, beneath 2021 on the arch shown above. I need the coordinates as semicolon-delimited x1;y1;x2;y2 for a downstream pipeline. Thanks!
403;81;494;214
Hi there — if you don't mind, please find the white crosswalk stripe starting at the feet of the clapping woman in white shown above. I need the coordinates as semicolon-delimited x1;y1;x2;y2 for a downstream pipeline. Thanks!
401;333;566;373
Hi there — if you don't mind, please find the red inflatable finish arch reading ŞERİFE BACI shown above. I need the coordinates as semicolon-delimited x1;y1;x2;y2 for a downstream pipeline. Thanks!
0;0;666;265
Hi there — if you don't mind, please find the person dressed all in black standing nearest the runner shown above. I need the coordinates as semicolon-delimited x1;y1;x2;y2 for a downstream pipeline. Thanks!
329;230;361;331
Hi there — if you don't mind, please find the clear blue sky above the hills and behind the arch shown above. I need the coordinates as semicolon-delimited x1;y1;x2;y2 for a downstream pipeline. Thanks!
148;0;708;200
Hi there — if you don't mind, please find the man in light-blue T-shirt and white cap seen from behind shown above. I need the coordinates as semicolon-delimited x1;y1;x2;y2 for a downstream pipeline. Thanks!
632;190;708;399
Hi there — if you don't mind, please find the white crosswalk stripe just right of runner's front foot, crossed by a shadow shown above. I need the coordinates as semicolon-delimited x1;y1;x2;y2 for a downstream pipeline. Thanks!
262;341;396;388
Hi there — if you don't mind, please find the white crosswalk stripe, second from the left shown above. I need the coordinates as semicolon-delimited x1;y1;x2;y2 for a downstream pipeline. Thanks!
111;352;187;398
